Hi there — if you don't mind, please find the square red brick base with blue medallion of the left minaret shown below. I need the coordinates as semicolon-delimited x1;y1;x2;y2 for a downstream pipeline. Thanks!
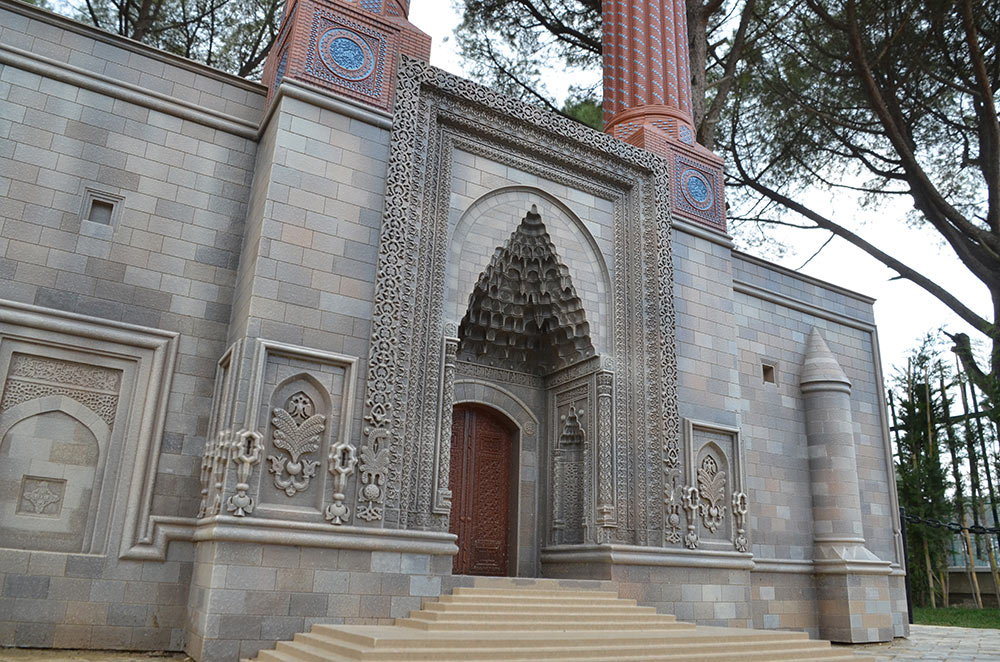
263;0;431;110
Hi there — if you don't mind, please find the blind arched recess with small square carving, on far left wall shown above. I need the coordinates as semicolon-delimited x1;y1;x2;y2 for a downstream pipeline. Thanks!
0;395;110;552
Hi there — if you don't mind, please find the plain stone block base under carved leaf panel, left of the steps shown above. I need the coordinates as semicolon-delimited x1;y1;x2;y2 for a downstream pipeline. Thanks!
184;542;458;660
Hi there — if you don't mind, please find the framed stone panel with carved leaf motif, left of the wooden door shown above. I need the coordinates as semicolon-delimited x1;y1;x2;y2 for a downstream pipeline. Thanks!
213;340;357;524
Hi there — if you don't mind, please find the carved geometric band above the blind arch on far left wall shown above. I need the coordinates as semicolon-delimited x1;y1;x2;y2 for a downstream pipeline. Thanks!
0;353;122;426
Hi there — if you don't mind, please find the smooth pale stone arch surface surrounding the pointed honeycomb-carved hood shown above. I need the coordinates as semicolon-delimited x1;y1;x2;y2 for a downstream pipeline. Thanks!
443;186;614;355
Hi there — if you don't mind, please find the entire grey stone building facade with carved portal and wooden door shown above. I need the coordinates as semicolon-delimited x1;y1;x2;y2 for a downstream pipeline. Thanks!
0;0;906;662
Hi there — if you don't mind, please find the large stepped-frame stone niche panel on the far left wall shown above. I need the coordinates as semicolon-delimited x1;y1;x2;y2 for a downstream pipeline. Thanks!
0;302;174;557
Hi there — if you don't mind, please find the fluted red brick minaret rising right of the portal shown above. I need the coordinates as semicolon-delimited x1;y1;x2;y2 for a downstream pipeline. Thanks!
602;0;726;231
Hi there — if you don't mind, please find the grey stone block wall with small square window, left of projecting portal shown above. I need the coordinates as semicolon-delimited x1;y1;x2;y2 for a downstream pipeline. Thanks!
0;3;264;650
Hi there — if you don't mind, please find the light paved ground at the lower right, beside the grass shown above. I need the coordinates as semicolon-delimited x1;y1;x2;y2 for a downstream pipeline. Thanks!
840;625;1000;662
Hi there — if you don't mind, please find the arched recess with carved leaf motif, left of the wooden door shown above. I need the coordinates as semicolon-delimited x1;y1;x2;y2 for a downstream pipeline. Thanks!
259;372;332;519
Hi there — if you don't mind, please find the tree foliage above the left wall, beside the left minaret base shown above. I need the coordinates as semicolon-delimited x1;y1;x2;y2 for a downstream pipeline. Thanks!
72;0;284;77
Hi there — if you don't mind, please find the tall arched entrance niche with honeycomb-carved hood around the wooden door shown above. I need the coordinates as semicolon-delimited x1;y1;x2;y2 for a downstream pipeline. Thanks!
437;195;616;575
